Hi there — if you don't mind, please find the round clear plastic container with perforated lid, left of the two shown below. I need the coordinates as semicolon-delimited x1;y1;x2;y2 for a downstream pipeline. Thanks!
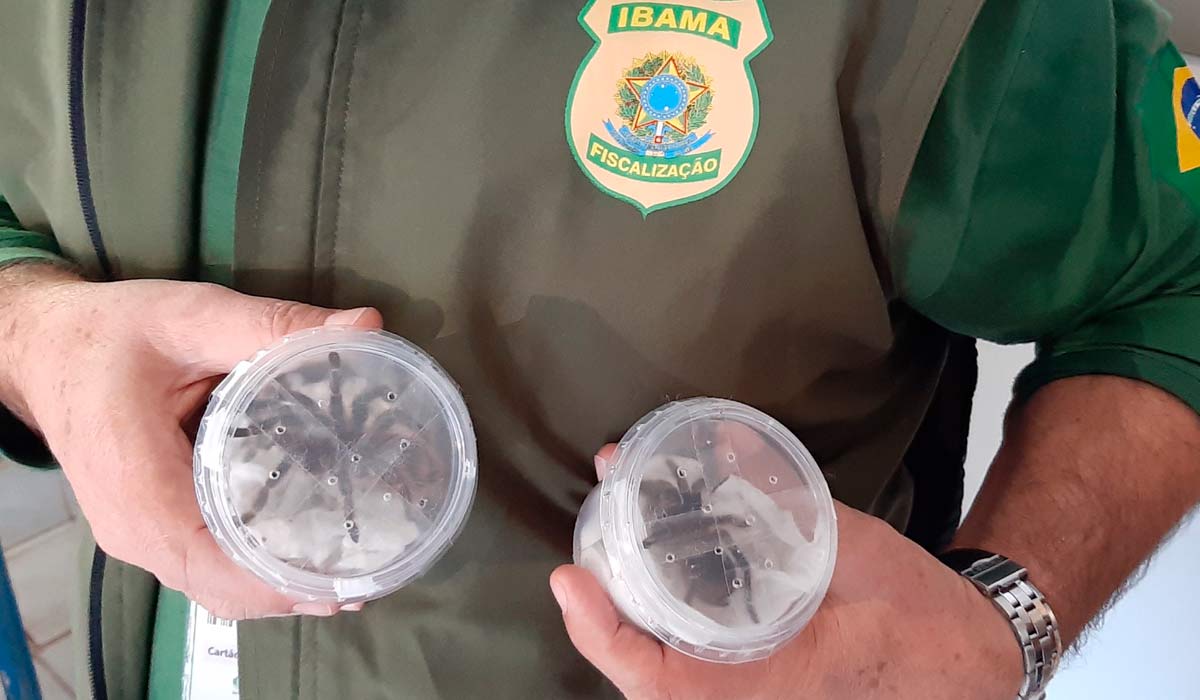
194;327;476;603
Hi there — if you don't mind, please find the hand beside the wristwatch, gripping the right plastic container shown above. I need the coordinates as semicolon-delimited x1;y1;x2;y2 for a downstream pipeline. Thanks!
551;450;1024;700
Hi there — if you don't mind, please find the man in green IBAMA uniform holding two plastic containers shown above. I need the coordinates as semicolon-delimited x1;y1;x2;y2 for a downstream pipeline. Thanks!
0;0;1200;699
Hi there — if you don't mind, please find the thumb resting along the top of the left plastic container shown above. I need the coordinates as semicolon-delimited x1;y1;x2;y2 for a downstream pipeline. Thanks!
169;287;383;373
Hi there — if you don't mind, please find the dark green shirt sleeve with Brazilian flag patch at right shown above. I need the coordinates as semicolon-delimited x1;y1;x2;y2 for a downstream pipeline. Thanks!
888;0;1200;411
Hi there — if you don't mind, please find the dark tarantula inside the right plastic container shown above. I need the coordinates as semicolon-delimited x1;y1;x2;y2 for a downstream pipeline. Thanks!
640;457;758;624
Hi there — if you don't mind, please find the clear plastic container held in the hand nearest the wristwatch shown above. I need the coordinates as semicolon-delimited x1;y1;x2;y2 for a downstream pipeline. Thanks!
575;399;838;663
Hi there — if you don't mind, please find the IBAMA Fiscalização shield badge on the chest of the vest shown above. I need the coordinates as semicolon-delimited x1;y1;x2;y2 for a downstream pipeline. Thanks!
566;0;772;216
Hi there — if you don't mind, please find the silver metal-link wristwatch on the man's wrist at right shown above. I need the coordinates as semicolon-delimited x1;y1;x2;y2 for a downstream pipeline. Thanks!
937;549;1062;700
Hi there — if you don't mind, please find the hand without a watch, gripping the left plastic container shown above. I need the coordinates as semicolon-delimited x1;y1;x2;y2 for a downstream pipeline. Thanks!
0;264;382;620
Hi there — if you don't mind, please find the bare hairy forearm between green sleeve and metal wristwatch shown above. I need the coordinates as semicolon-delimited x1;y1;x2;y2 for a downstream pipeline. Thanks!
954;376;1200;644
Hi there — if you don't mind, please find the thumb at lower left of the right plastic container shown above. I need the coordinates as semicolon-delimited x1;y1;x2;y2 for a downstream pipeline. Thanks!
550;566;664;698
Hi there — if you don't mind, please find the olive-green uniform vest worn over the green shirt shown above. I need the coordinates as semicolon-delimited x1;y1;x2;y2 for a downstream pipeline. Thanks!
17;0;980;699
